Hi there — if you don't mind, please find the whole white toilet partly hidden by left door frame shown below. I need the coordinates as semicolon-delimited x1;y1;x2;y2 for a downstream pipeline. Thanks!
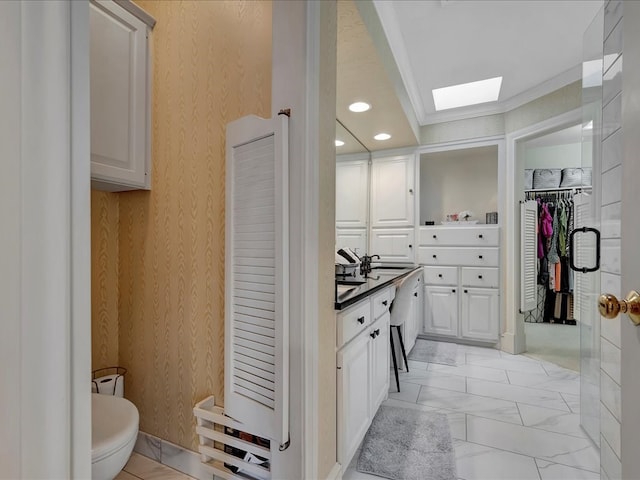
91;393;139;480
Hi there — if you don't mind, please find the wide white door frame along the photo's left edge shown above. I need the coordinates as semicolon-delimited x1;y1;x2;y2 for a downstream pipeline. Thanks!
0;2;91;478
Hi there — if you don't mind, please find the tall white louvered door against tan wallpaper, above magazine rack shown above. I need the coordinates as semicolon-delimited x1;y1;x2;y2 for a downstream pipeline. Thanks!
224;115;289;445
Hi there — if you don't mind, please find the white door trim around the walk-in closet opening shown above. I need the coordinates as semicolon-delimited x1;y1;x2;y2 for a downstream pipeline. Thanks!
500;108;582;354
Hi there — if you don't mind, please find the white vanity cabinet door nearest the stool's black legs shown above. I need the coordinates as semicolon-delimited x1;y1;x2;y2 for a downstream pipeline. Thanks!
369;311;390;415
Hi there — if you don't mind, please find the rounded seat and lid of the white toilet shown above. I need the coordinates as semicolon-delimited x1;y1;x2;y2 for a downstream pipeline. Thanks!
91;393;139;463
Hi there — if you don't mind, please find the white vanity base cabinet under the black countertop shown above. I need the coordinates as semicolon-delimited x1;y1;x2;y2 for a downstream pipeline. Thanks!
336;287;394;465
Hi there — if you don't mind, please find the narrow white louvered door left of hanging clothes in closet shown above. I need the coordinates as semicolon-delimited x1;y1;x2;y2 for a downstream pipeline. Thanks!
520;200;538;312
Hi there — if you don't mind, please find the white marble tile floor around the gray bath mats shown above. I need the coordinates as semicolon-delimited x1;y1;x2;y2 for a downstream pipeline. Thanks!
343;345;600;480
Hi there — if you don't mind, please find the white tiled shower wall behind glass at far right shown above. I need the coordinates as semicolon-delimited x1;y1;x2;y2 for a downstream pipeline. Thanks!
600;0;623;480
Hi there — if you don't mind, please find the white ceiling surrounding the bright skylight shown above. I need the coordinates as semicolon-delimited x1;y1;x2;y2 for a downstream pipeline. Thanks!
372;0;602;125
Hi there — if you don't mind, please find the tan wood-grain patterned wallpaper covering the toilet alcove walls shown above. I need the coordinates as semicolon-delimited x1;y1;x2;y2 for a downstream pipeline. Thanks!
92;0;271;450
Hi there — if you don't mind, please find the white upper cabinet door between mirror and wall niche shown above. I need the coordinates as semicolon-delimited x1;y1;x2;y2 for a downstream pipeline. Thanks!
371;155;415;228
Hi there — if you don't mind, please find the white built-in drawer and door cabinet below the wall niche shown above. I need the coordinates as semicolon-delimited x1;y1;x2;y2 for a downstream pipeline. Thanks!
418;225;500;343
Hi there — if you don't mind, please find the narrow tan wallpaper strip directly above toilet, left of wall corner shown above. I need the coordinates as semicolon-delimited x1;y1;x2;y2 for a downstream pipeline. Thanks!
91;190;119;370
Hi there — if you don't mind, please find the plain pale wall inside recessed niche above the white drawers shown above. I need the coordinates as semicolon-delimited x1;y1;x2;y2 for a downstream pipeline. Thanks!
420;146;498;225
